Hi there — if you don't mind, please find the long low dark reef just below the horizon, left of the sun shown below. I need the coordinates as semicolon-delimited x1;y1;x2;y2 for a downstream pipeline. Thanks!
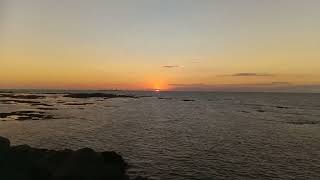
64;93;136;99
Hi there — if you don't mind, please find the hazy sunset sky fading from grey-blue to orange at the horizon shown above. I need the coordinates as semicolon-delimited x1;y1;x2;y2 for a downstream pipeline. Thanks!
0;0;320;92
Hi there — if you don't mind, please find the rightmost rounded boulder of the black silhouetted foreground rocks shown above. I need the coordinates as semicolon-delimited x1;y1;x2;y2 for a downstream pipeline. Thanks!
53;148;127;180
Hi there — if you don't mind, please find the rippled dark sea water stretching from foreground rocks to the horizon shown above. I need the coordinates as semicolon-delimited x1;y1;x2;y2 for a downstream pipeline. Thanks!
0;91;320;180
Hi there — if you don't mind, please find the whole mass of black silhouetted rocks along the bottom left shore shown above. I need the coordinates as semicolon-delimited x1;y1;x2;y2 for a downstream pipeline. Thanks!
0;137;147;180
